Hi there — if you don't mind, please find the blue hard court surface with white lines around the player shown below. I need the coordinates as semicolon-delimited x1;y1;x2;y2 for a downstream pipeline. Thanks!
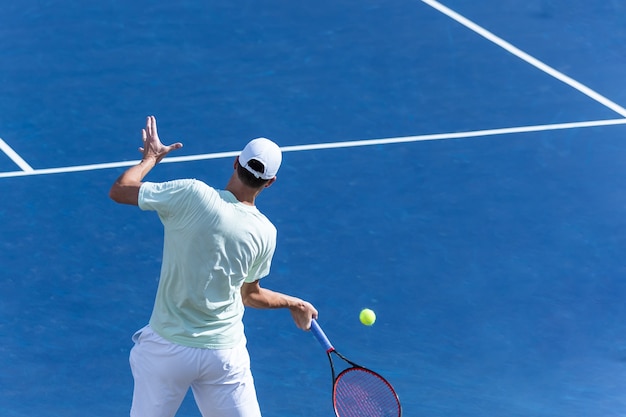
0;0;626;417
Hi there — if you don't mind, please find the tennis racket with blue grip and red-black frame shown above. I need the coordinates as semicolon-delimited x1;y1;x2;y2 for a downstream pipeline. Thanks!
311;320;402;417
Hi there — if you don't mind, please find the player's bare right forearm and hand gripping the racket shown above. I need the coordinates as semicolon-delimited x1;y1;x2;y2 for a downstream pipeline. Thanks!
241;280;317;330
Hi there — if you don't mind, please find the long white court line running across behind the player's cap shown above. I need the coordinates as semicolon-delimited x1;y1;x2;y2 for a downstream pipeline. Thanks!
0;119;626;178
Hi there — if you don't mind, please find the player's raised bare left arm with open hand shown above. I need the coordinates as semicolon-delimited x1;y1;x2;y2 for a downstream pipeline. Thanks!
109;116;183;206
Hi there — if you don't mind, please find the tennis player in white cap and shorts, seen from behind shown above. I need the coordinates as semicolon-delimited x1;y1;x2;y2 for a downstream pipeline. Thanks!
110;116;317;417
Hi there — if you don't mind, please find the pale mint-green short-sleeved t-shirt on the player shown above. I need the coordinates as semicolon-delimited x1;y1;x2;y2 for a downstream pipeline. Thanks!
139;179;276;349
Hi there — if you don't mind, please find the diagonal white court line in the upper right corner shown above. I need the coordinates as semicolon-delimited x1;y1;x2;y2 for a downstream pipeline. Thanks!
422;0;626;117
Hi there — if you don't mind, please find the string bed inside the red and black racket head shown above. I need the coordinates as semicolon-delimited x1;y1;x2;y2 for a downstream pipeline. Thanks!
333;368;401;417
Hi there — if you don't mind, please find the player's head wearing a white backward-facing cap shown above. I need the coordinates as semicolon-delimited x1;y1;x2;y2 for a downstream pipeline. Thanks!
237;138;283;188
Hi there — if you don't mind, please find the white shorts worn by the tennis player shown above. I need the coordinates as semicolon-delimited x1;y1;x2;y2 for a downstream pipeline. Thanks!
130;326;261;417
